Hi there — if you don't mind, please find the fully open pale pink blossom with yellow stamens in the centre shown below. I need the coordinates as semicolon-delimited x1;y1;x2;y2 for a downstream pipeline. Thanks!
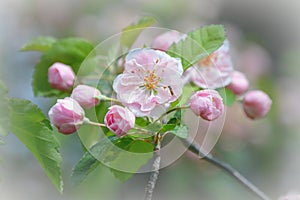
113;49;183;117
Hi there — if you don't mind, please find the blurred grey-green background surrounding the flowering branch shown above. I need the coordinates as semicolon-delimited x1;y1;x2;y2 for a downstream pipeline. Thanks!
0;0;300;200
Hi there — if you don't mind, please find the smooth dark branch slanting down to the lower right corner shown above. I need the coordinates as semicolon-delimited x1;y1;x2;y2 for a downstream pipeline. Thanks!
182;139;271;200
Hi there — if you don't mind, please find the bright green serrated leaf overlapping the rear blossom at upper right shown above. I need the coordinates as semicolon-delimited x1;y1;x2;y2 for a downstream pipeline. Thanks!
167;25;225;70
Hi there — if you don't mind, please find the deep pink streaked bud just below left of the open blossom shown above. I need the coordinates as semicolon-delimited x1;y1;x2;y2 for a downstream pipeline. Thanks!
104;105;135;137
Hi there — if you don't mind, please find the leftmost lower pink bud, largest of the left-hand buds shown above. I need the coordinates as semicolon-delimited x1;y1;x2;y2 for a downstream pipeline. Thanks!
48;97;84;135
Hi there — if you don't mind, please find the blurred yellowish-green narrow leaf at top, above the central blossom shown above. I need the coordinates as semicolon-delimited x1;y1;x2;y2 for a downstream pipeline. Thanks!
121;16;156;49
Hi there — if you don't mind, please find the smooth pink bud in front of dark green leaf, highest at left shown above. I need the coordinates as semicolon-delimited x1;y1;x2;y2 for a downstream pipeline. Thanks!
48;62;75;91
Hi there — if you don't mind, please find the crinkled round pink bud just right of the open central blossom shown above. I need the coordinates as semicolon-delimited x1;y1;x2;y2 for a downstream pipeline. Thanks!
190;90;224;121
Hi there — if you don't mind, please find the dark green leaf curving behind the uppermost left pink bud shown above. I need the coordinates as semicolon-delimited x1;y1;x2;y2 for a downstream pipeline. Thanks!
32;38;93;97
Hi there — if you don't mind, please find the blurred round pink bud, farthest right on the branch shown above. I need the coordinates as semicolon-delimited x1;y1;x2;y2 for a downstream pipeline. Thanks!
243;90;272;119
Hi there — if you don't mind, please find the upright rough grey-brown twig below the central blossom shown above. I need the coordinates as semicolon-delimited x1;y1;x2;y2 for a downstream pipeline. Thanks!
144;134;161;200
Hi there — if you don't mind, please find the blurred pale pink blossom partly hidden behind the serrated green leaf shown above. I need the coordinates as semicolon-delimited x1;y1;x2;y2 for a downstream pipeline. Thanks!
185;40;233;89
